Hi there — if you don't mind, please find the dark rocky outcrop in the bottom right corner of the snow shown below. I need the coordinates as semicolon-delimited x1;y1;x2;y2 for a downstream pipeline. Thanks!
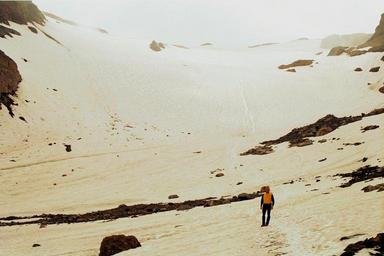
341;233;384;256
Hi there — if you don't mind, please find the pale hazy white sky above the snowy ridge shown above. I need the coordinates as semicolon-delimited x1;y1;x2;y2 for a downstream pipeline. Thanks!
34;0;384;46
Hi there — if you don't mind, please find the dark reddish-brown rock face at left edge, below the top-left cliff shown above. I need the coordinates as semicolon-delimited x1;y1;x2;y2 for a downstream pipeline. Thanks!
0;50;22;116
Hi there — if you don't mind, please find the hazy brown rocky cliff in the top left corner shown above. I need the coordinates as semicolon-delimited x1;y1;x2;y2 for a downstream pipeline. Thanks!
0;1;45;25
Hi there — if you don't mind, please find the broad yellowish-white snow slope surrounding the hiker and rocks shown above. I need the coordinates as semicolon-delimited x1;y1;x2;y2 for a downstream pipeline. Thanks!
0;15;384;255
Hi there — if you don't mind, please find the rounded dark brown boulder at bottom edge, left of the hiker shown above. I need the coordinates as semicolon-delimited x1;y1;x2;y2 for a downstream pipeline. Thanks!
99;235;141;256
